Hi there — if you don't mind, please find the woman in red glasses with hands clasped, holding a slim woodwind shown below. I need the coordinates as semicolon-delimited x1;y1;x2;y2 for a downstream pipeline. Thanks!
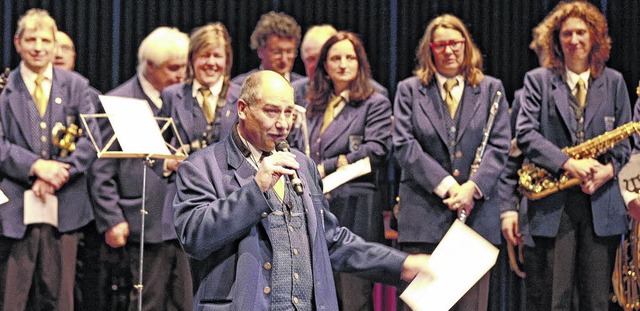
393;14;511;310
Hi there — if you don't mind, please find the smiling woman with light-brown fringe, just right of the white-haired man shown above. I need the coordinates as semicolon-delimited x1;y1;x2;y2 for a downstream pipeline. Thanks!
159;22;240;225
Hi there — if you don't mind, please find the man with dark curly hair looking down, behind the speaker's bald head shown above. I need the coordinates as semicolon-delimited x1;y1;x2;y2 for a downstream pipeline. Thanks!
231;12;304;85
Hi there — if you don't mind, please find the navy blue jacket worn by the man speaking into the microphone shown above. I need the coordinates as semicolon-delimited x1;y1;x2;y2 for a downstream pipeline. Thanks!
174;135;406;311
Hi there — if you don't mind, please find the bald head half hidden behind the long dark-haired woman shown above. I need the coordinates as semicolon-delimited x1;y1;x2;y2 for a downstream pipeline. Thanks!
300;25;337;80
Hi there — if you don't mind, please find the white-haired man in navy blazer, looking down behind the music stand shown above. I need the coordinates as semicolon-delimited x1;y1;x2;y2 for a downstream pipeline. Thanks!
92;27;193;310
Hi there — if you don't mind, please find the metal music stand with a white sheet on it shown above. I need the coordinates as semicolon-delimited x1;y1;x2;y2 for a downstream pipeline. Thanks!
80;95;187;310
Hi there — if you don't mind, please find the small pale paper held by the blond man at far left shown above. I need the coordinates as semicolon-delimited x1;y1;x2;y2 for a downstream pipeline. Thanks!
24;190;58;228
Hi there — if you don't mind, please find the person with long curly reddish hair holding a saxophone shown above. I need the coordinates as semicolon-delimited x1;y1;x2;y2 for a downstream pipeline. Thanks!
516;1;631;310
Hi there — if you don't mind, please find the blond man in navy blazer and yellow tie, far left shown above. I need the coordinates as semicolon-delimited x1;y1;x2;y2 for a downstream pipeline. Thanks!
0;9;100;310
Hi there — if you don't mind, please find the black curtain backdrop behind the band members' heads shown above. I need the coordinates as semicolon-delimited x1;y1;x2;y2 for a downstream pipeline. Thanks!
0;0;640;105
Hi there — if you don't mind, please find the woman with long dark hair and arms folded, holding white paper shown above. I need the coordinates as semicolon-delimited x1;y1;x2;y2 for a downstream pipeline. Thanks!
307;32;391;310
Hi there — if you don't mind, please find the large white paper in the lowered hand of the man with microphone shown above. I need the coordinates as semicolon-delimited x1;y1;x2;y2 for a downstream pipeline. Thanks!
400;220;498;311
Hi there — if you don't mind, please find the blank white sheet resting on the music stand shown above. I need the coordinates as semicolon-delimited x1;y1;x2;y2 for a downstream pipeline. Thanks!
99;95;171;155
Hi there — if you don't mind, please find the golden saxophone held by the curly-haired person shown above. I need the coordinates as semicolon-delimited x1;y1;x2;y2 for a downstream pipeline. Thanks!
518;122;640;200
